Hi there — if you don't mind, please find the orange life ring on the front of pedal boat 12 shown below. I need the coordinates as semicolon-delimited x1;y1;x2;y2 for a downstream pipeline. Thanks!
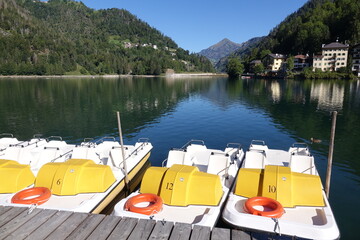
124;193;163;215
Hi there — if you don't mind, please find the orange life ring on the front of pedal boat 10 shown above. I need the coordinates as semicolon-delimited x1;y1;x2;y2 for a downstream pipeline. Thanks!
245;197;285;218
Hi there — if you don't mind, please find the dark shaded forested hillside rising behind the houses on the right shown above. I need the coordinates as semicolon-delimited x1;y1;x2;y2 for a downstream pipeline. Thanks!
231;0;360;65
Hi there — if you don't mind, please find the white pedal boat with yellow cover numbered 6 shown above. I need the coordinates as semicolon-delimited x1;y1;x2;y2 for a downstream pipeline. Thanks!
1;138;152;213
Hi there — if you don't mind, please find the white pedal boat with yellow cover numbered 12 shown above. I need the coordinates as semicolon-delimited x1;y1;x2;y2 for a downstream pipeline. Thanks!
113;140;244;228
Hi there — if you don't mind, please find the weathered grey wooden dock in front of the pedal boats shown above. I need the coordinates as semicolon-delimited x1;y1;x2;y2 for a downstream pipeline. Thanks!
0;206;292;240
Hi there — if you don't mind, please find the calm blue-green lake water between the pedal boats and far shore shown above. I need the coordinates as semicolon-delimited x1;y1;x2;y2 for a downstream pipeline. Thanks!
0;77;360;239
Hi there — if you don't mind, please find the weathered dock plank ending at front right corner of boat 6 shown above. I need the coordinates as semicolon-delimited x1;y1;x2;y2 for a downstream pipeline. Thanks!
67;214;105;240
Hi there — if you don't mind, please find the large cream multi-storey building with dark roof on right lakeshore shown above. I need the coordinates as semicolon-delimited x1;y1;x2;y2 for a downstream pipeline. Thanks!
313;41;349;71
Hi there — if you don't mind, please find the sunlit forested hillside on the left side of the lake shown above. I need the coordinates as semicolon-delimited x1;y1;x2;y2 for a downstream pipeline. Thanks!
0;0;214;75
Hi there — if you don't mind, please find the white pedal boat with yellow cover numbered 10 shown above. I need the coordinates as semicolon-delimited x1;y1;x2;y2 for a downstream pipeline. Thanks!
222;140;340;239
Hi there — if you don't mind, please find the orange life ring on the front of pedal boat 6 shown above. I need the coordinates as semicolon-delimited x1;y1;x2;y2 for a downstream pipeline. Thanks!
11;187;51;205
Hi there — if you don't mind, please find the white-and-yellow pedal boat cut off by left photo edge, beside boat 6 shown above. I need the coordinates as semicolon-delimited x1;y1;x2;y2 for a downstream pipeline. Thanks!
0;135;75;205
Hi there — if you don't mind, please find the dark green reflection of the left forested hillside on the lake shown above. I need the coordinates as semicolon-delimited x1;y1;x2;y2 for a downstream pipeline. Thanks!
0;78;214;141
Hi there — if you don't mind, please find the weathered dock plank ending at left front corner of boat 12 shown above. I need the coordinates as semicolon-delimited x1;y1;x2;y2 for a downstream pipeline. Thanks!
87;216;121;240
